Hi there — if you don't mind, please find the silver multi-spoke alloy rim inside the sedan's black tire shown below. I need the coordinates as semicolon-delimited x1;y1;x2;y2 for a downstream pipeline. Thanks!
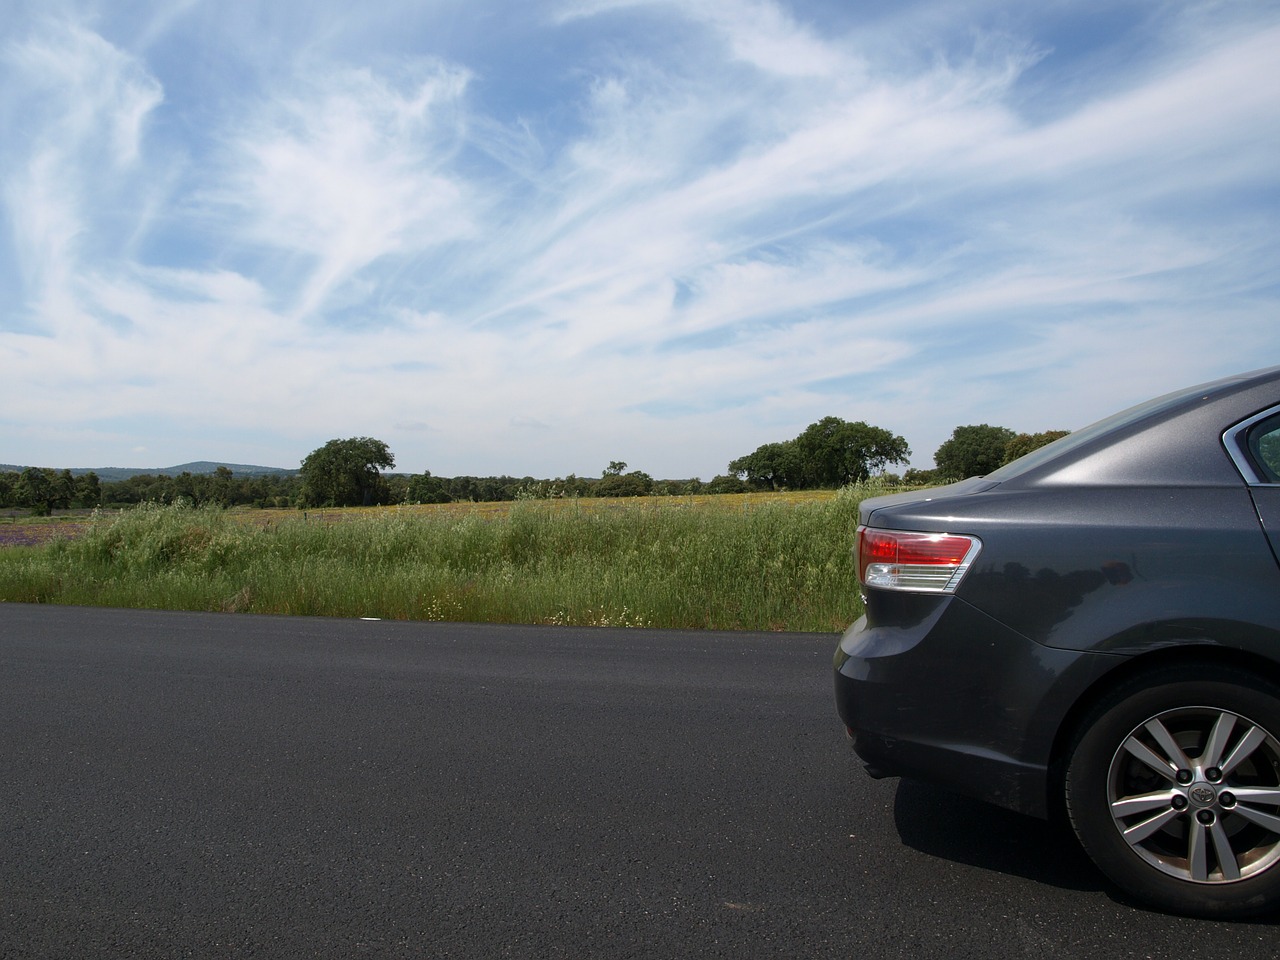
1107;707;1280;884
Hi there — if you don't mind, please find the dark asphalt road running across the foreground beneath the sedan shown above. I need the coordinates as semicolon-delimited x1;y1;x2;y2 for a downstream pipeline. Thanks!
0;604;1280;960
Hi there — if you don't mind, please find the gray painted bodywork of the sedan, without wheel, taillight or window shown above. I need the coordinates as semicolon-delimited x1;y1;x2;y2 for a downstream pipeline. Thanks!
835;367;1280;815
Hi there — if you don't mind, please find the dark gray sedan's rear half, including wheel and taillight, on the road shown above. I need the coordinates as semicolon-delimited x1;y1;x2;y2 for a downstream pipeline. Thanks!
836;367;1280;918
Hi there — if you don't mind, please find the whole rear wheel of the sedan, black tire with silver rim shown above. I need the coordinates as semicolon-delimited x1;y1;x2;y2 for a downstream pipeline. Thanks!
1065;666;1280;919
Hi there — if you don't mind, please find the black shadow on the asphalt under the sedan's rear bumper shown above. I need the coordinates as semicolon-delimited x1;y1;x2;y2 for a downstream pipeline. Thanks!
893;780;1107;891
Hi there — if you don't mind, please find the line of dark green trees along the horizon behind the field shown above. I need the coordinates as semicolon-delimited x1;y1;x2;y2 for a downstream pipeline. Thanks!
0;416;1068;516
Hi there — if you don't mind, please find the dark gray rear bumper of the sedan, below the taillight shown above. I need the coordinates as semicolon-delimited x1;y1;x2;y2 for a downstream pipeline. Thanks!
836;595;1114;817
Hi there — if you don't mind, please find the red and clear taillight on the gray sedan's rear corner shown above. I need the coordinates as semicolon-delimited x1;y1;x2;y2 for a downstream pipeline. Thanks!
858;526;982;593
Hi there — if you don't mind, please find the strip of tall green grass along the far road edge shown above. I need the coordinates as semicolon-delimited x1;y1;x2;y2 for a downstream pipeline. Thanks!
0;488;881;631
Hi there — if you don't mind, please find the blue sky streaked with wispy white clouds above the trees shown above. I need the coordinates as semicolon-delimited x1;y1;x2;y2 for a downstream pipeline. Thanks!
0;0;1280;480
